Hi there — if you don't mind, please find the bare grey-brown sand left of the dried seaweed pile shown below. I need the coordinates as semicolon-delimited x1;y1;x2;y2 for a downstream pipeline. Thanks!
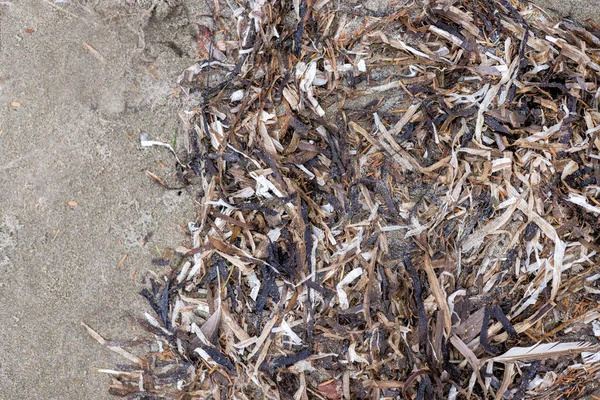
0;0;203;399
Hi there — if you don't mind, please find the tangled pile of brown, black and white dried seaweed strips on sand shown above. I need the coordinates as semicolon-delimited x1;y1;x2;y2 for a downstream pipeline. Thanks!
85;0;600;399
